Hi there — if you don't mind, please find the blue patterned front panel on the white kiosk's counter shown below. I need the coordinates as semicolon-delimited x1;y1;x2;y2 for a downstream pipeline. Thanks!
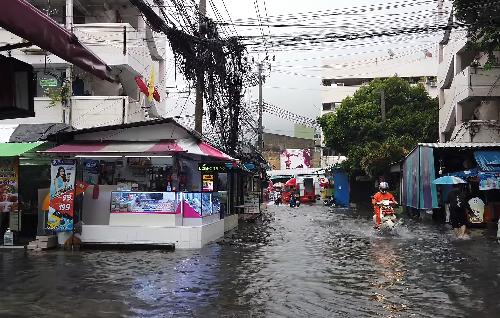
111;191;180;214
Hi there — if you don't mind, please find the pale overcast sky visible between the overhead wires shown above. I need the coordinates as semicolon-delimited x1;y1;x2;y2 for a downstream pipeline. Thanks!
166;0;448;135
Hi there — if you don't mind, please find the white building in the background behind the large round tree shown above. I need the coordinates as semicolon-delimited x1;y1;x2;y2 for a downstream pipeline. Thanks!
321;51;438;167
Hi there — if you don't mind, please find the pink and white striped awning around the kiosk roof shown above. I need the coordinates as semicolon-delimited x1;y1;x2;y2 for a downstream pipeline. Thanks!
42;139;233;160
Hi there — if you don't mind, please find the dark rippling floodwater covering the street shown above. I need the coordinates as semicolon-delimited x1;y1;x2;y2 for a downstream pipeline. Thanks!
0;206;500;317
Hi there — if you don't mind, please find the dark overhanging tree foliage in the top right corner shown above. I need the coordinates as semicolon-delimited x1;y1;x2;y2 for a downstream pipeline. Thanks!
453;0;500;67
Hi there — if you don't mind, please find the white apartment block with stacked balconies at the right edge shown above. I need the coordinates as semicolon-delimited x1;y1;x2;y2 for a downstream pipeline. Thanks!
438;30;500;143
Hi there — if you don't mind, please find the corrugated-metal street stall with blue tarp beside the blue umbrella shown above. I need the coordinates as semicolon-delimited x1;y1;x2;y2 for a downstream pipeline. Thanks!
401;143;500;224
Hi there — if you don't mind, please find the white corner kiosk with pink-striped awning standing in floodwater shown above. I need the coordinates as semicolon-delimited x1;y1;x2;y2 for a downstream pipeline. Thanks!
39;119;237;248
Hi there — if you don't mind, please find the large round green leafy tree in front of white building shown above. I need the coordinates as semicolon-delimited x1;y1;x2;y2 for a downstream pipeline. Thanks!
318;77;439;178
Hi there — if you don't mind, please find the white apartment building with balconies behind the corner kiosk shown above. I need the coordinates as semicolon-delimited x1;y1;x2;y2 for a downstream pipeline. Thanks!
0;0;166;129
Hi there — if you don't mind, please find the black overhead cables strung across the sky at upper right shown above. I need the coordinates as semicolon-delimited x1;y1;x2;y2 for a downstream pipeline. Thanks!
216;0;480;51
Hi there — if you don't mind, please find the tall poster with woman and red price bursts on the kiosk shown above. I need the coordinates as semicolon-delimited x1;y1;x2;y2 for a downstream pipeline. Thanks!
47;160;76;232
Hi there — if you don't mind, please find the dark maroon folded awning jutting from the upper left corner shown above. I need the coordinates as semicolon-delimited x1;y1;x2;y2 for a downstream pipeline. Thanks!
0;0;113;81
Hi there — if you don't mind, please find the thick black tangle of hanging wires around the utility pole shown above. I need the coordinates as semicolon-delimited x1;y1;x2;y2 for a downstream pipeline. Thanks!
130;0;255;155
